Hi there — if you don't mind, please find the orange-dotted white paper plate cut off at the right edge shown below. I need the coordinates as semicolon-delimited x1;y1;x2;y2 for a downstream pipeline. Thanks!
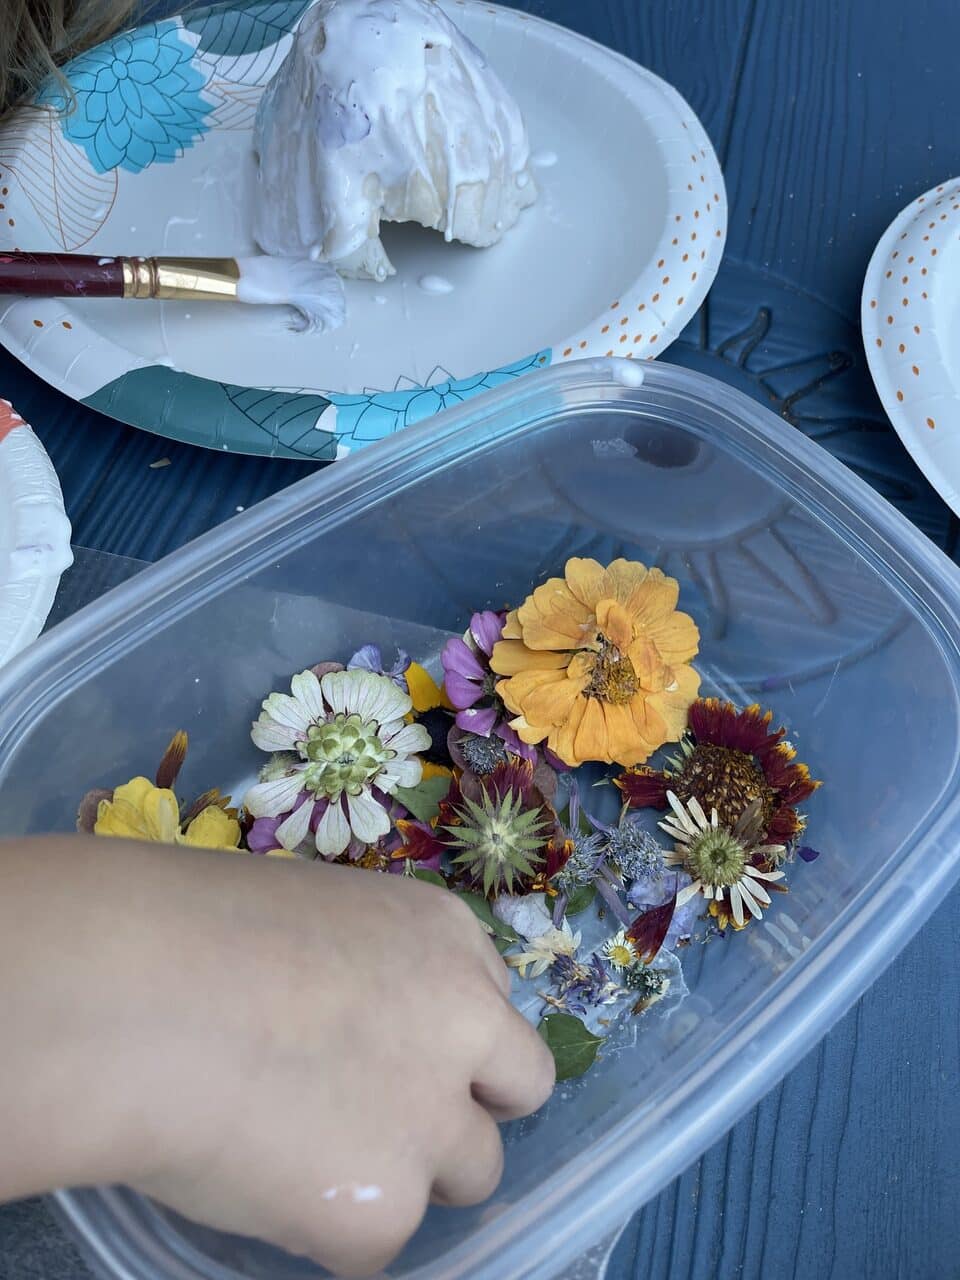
860;178;960;513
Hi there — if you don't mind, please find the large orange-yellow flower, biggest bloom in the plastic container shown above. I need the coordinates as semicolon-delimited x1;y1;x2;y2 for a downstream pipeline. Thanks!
490;558;700;765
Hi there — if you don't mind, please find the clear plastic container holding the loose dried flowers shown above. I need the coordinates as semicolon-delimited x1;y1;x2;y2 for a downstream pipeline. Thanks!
0;361;960;1280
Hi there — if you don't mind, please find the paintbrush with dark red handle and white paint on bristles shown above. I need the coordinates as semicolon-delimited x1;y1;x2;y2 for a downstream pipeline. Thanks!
0;250;346;332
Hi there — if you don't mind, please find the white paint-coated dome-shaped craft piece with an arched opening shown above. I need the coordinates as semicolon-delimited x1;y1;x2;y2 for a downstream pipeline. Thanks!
253;0;536;280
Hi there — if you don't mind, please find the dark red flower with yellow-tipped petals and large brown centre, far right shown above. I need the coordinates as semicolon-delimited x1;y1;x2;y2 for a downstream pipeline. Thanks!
617;698;820;845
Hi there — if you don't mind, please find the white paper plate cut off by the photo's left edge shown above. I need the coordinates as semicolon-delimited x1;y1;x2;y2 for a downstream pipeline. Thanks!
0;401;73;663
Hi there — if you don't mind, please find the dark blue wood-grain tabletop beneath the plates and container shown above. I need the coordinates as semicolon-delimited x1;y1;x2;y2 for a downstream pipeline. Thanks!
0;0;960;1280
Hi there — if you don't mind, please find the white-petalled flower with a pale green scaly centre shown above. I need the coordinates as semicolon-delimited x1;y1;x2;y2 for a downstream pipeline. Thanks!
243;671;430;858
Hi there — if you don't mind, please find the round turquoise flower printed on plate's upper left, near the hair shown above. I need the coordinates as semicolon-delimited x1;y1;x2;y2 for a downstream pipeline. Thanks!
41;22;214;173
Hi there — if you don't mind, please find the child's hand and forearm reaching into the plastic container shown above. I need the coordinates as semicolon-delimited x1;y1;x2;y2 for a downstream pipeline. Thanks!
0;837;553;1275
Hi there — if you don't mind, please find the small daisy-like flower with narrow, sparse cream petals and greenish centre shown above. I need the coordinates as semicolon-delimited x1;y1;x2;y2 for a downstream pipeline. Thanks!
660;791;785;925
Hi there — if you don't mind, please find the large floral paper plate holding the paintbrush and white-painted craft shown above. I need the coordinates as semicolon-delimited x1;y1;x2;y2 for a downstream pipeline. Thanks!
0;0;726;458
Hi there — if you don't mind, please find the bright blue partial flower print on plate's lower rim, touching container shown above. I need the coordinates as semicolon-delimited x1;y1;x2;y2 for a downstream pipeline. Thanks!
326;347;553;449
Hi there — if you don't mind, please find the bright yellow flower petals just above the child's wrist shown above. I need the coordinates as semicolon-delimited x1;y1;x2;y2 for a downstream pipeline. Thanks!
93;778;241;849
